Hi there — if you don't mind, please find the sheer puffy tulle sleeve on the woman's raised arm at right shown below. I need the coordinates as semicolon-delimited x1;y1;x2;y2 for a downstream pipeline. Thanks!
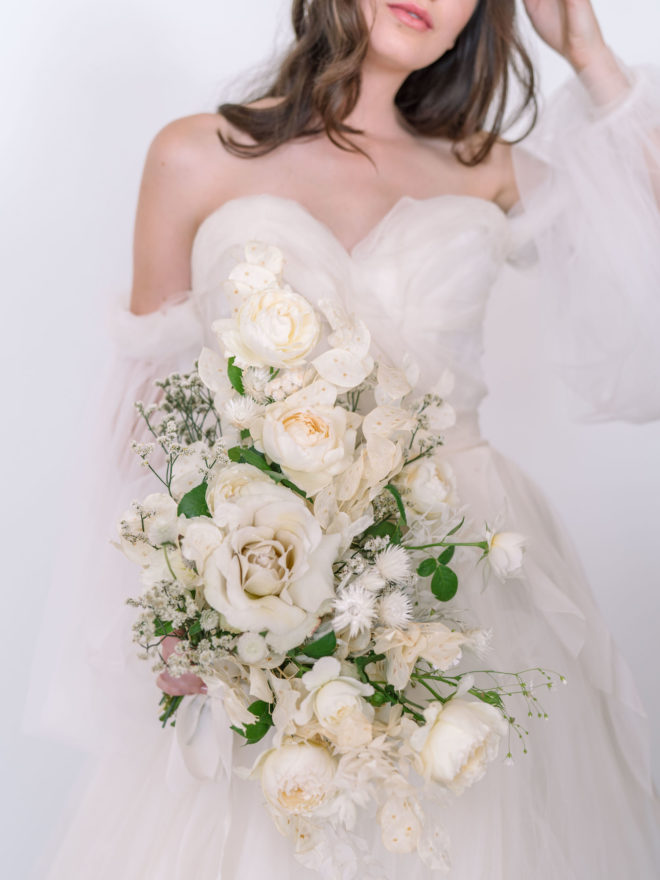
509;58;660;423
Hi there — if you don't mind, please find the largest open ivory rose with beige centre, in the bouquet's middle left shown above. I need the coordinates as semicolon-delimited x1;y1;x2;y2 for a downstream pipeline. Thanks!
181;480;339;651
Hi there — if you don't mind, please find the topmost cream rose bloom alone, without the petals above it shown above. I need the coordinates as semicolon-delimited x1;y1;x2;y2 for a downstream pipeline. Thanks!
211;285;321;369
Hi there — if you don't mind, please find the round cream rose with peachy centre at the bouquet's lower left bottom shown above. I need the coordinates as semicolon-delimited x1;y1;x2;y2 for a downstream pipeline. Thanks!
250;742;337;815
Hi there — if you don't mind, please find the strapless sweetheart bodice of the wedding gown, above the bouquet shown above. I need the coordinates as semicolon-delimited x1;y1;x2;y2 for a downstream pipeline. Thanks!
192;194;512;426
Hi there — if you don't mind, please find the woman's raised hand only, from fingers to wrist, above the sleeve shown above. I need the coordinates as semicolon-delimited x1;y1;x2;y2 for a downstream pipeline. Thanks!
523;0;610;73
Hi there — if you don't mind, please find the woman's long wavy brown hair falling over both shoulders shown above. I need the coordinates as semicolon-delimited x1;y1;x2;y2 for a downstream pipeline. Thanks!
217;0;538;166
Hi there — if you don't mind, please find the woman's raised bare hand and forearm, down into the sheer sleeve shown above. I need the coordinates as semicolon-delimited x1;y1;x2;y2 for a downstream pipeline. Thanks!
523;0;629;105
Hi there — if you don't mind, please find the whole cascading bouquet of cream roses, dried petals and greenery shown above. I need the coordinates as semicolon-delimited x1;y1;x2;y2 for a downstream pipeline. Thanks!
117;241;565;876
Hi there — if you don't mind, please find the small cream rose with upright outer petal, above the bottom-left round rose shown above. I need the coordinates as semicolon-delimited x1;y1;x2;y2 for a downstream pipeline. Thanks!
293;657;374;748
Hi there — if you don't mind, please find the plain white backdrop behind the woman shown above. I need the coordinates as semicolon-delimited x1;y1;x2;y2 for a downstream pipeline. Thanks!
0;0;660;880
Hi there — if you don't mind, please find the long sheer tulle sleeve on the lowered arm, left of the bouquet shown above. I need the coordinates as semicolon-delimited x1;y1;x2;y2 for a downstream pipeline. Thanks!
22;291;203;752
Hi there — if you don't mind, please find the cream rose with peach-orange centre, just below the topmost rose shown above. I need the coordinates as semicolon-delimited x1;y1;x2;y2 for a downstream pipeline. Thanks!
250;381;360;495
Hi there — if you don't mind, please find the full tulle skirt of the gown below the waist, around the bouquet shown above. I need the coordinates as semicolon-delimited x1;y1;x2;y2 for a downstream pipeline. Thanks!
29;441;660;880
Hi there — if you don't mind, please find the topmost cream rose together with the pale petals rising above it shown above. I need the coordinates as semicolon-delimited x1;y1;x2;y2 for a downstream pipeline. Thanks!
211;242;321;369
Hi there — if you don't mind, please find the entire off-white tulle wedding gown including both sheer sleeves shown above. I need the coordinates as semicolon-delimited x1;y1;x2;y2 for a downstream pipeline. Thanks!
25;56;660;880
